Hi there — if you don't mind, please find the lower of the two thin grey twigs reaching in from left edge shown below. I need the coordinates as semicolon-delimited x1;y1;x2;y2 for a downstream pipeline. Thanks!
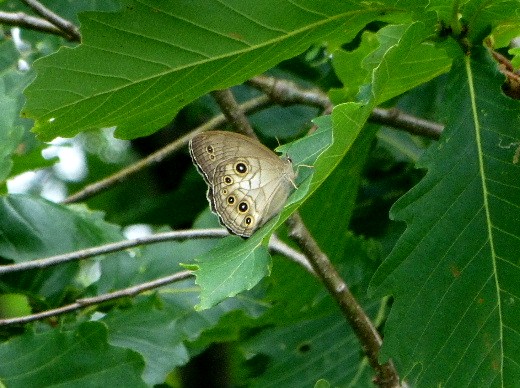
0;271;193;326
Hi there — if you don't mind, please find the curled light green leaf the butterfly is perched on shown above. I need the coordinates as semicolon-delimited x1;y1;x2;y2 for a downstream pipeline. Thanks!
188;98;370;309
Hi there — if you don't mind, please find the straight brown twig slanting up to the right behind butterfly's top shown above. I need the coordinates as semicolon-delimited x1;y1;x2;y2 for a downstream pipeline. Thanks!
62;96;272;203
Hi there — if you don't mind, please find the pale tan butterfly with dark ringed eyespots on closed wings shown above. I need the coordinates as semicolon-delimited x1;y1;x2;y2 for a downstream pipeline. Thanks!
190;131;295;237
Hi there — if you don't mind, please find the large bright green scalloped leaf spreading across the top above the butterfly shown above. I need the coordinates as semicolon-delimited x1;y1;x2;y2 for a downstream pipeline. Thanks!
24;0;424;140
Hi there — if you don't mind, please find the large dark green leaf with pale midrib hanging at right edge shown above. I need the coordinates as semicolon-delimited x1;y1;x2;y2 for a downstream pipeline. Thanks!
372;49;520;387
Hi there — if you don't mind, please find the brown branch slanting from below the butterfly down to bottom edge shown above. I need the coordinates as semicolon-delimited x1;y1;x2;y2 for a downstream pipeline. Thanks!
288;213;399;387
